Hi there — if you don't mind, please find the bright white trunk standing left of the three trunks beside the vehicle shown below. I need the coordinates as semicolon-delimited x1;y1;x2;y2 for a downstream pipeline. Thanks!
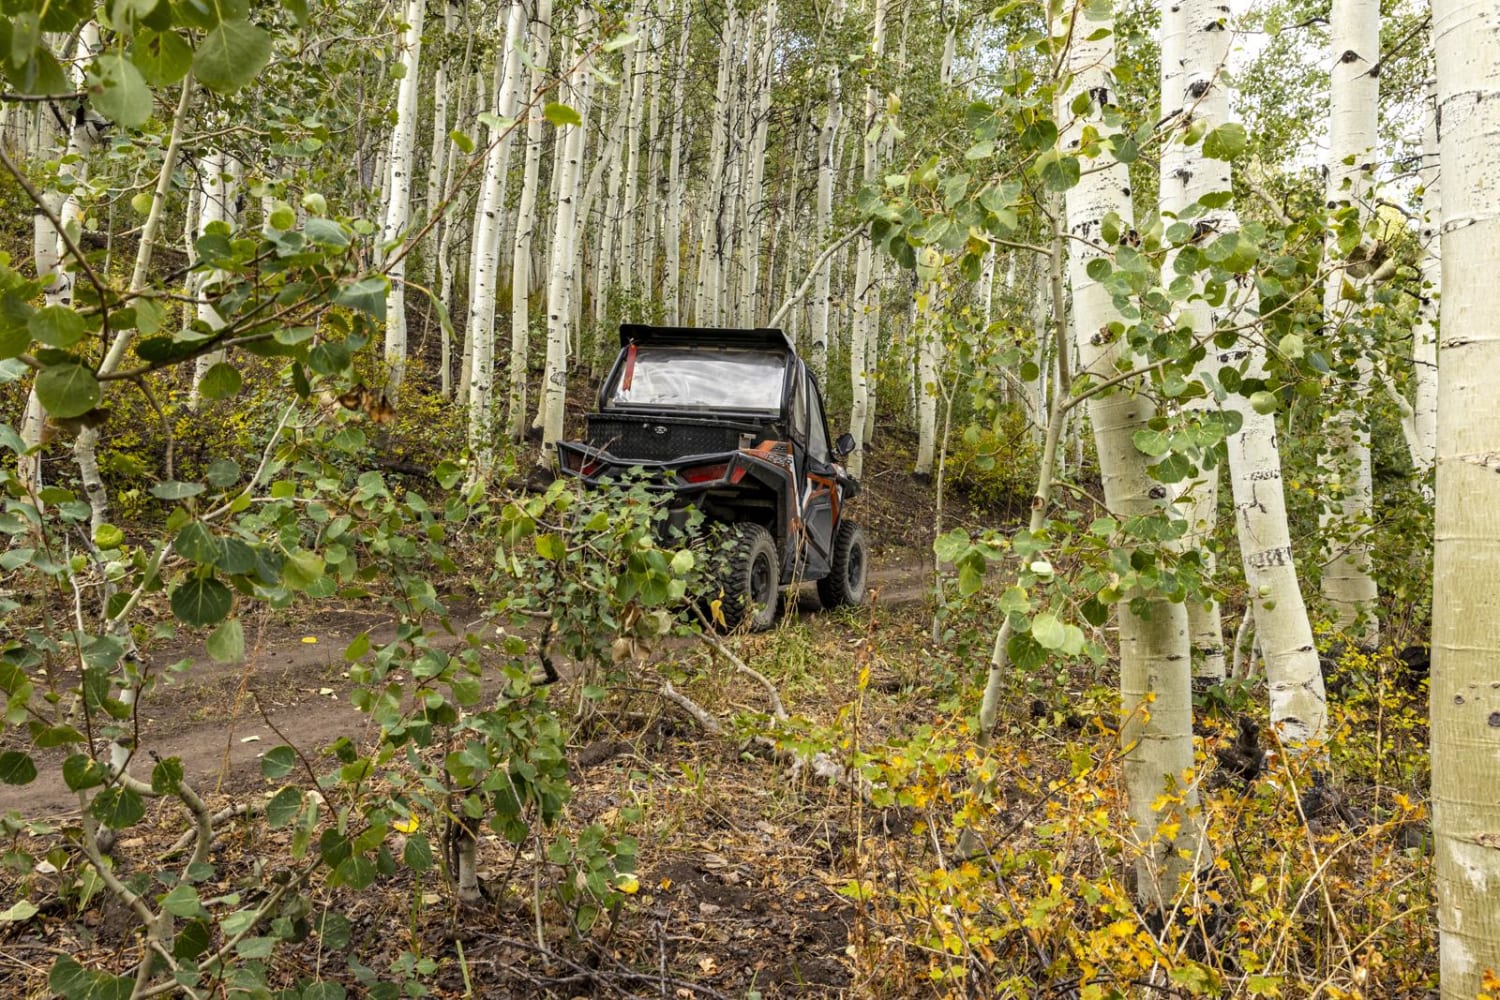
381;0;428;394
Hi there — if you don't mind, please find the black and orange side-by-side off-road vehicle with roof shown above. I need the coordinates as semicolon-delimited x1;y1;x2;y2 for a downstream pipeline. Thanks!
558;324;869;628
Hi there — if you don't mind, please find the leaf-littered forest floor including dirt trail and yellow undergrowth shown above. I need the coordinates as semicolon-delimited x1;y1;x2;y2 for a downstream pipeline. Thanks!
0;442;1436;1000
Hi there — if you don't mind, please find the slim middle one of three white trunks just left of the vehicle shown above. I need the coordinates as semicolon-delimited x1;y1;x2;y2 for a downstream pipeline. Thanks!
506;0;552;441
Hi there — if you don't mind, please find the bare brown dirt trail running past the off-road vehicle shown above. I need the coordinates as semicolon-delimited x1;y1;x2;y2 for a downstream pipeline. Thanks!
0;550;930;820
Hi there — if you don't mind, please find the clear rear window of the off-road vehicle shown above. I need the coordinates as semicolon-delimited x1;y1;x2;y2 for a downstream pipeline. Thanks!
609;345;786;412
